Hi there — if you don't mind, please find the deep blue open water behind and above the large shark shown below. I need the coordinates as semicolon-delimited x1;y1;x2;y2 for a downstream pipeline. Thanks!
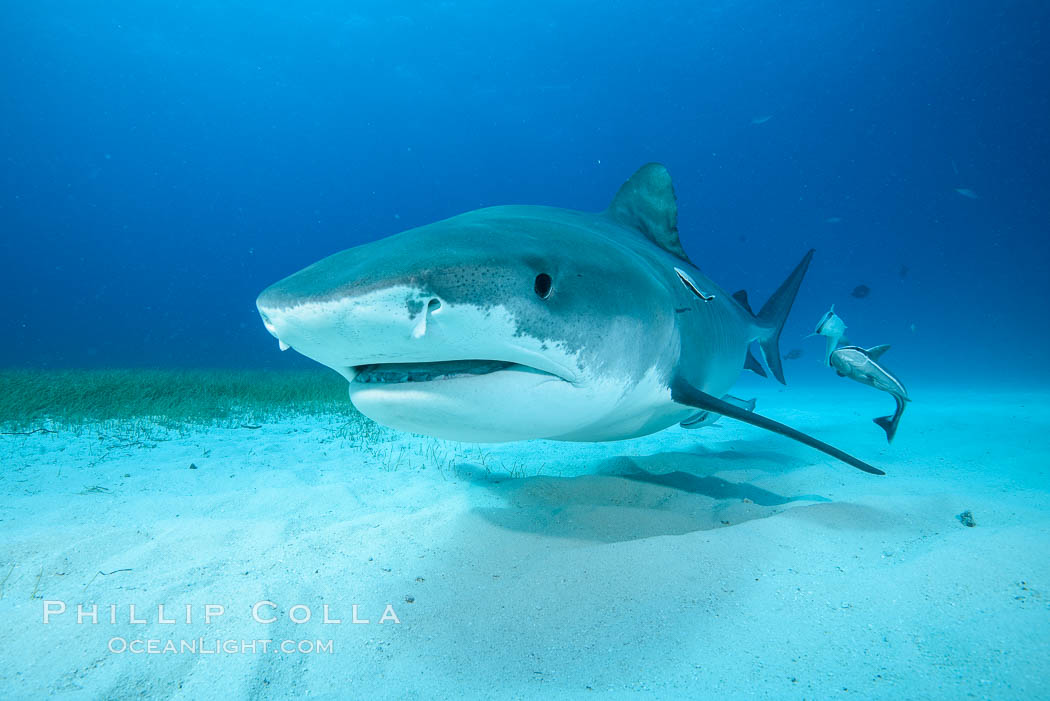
0;0;1050;383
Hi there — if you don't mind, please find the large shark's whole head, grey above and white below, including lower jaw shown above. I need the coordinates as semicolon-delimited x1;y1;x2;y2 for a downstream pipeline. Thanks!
256;202;675;442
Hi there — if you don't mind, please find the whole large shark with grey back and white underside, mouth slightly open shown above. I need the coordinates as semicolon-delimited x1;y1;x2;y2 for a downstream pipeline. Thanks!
256;164;883;474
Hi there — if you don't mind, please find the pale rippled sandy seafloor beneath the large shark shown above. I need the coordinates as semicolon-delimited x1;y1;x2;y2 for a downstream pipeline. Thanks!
0;385;1050;701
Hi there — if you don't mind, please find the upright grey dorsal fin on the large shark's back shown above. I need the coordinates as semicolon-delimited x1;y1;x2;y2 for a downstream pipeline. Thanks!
606;163;689;261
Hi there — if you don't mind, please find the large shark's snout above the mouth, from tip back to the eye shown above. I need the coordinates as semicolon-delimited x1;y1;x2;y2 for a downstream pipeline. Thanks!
256;220;581;383
